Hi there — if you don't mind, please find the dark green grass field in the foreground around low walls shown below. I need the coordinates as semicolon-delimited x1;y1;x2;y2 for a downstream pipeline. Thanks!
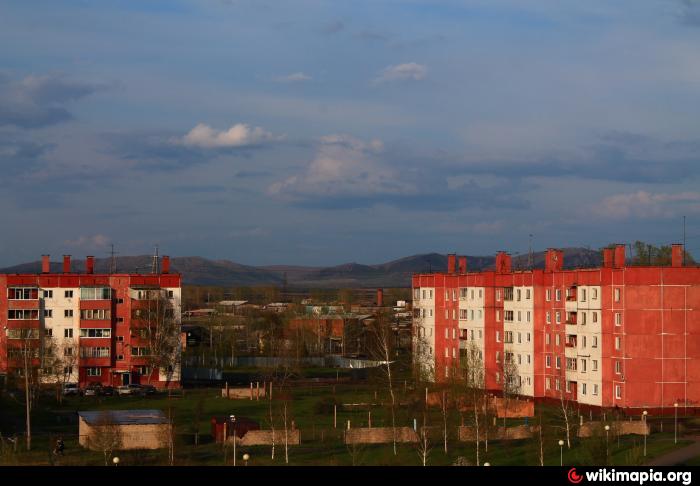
0;384;688;466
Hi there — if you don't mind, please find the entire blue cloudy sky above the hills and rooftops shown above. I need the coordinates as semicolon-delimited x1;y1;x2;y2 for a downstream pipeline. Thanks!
0;0;700;265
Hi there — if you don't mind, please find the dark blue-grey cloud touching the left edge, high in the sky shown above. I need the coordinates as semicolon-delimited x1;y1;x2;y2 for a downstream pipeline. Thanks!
0;75;105;128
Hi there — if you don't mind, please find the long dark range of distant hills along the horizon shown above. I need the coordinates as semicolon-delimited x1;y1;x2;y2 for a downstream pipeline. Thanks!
0;248;601;288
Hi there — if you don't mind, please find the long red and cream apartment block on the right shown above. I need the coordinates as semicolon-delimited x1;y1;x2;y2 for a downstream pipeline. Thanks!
412;244;700;410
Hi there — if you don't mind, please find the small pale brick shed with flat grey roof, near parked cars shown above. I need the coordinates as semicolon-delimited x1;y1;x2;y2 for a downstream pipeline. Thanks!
78;410;171;450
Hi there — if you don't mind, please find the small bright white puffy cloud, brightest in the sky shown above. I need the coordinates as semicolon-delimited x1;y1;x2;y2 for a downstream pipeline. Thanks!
174;123;284;148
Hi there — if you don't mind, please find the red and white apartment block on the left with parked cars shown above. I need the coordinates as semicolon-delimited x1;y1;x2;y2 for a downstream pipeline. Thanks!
0;255;181;387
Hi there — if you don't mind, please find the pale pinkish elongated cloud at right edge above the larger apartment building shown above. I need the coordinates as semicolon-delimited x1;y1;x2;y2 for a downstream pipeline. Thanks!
594;191;700;219
